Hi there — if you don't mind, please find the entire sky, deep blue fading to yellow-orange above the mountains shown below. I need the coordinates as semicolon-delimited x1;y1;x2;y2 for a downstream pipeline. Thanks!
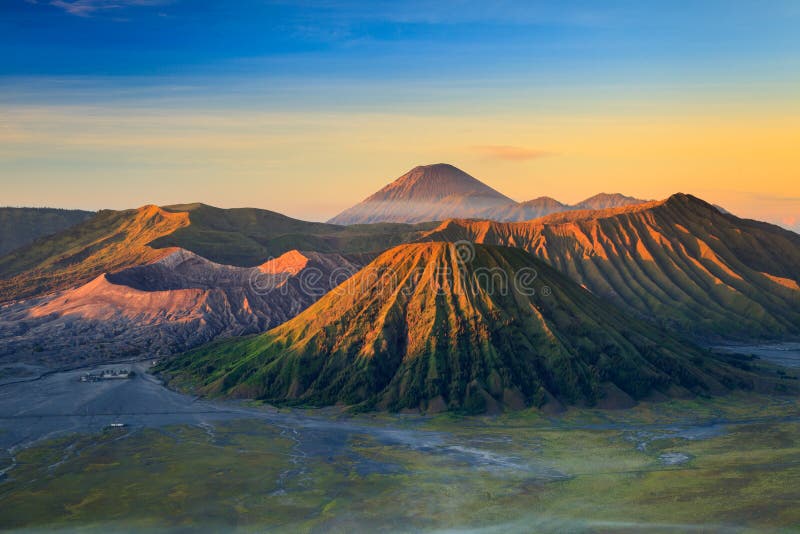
0;0;800;231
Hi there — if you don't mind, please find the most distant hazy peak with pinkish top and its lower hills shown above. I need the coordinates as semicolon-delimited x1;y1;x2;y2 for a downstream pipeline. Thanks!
328;163;644;225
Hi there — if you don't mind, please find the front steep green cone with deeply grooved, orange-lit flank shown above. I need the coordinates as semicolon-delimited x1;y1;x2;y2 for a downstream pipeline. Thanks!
159;243;756;412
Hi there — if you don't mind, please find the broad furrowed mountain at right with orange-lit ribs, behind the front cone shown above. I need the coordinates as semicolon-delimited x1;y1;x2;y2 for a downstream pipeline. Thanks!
426;194;800;338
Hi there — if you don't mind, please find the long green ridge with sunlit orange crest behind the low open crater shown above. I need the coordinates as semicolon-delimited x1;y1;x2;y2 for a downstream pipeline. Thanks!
0;203;433;303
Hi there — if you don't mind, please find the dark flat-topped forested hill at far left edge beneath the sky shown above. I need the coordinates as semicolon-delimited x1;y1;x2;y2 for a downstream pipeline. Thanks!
0;208;94;256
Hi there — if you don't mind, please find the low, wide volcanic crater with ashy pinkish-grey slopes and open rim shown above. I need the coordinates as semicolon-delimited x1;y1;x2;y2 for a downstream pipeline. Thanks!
0;249;360;365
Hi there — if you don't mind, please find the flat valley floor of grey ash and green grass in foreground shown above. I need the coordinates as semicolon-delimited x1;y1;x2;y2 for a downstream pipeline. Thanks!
0;354;800;532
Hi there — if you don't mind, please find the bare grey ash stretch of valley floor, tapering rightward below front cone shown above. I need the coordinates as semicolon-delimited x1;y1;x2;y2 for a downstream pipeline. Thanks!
0;361;562;478
